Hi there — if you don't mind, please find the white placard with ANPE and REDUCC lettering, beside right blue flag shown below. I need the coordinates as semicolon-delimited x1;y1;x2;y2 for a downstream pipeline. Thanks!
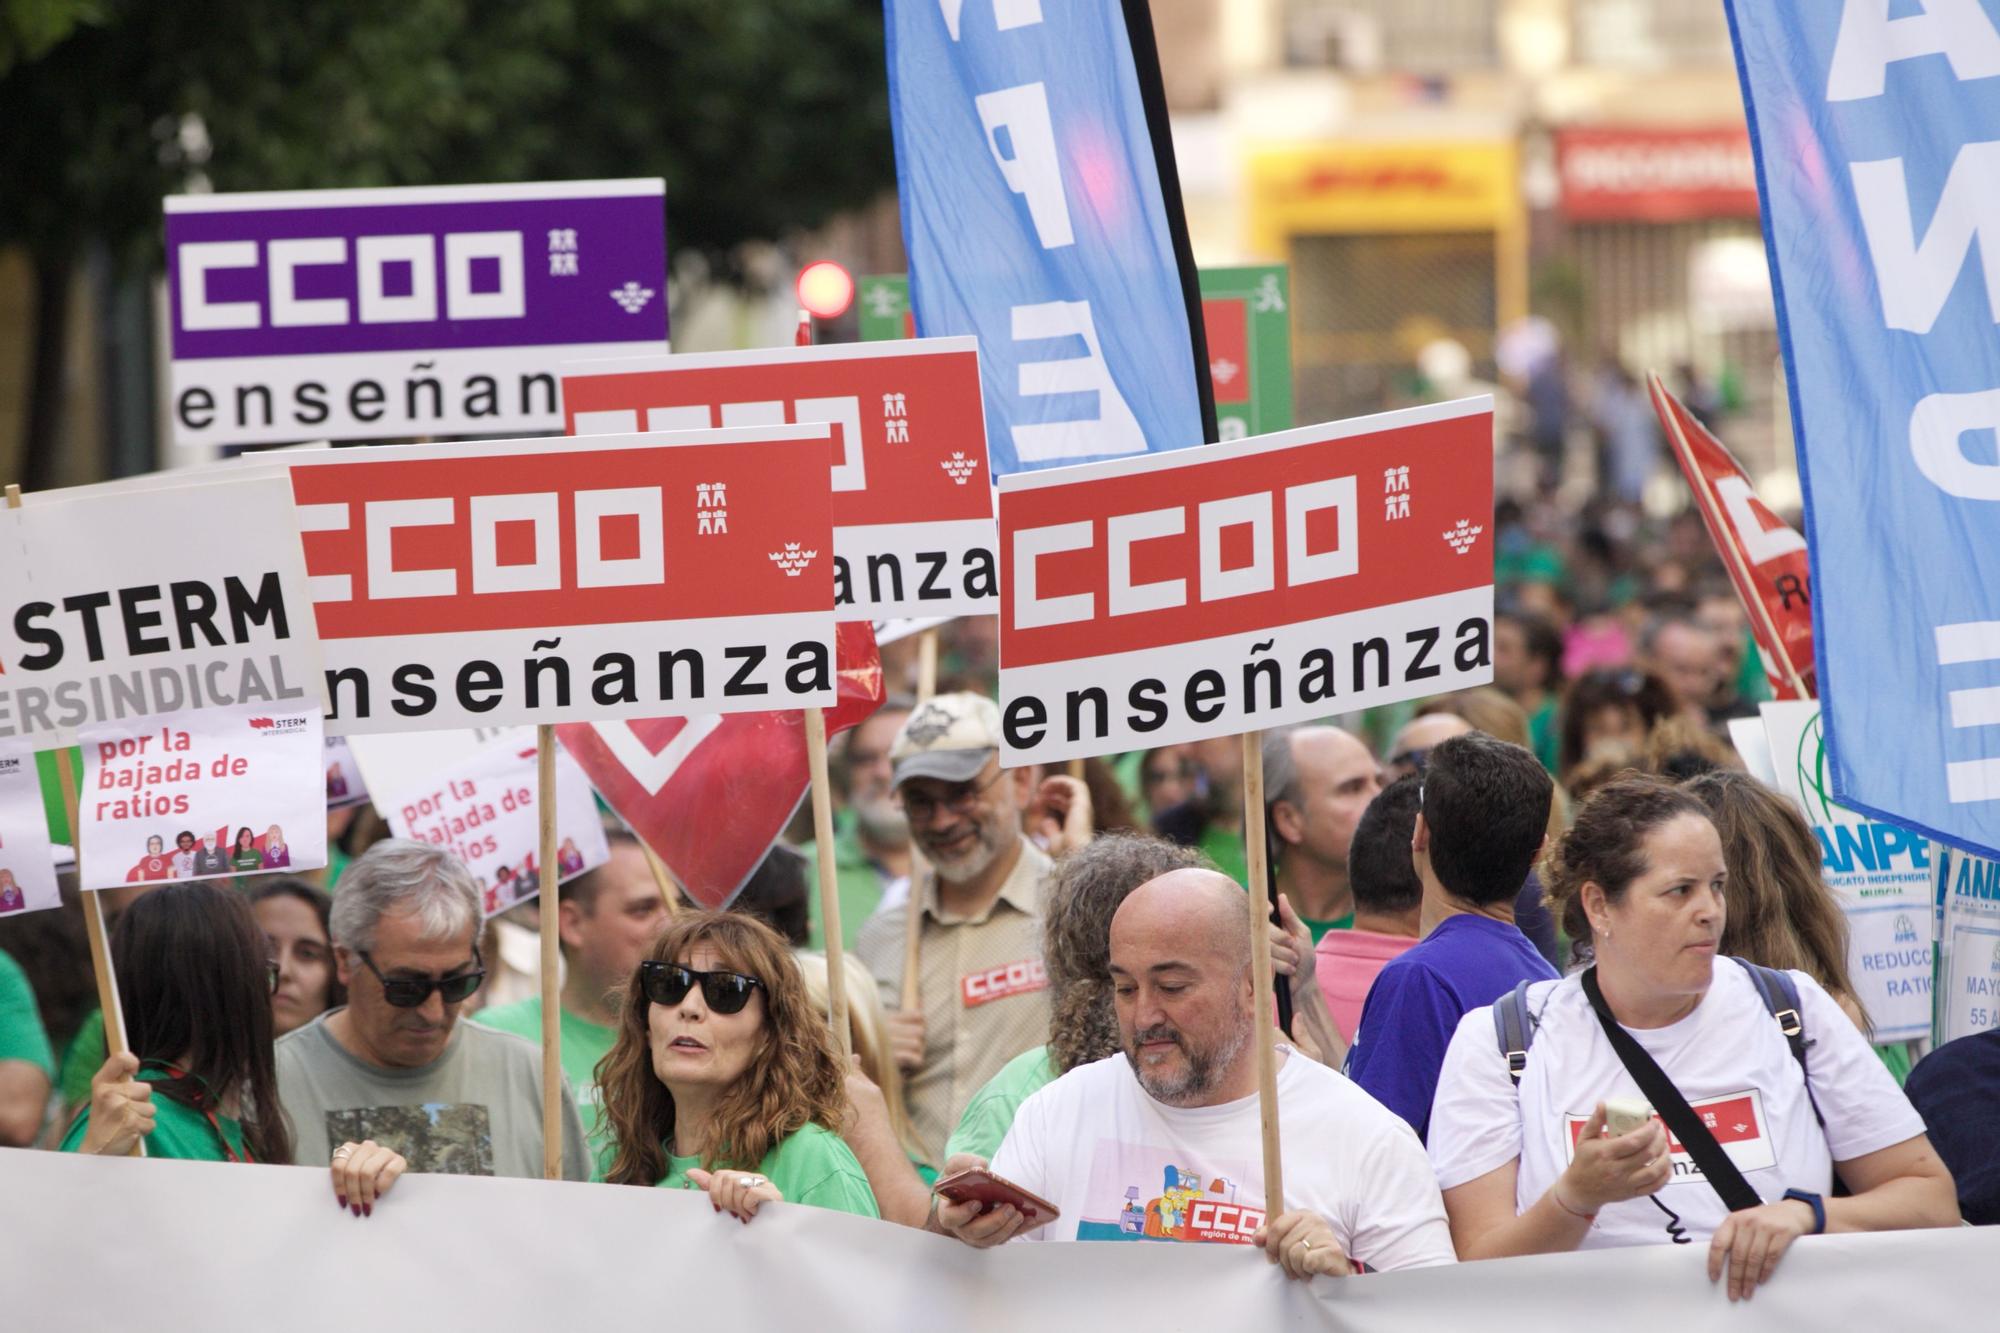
1760;701;1934;1041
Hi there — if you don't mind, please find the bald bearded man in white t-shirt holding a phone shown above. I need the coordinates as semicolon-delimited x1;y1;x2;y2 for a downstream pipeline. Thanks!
932;869;1454;1279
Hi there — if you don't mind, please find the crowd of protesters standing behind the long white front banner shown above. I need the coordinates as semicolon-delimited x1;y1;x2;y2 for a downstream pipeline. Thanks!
0;474;2000;1297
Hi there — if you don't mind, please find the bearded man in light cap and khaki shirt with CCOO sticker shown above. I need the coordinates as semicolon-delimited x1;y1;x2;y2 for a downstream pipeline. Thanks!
854;695;1090;1161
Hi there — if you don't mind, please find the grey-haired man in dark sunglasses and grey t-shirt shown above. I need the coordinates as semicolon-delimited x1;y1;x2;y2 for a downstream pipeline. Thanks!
278;839;590;1181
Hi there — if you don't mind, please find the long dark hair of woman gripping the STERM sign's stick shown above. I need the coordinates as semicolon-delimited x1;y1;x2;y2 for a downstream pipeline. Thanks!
101;881;292;1167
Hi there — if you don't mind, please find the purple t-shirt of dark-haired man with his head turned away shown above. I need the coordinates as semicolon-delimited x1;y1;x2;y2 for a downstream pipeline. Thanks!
1348;913;1556;1139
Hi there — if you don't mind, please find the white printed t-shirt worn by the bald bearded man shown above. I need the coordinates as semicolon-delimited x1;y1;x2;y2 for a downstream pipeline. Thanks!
992;1047;1456;1269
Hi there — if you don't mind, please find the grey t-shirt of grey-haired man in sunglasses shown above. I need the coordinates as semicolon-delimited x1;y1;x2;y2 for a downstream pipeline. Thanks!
278;1009;590;1181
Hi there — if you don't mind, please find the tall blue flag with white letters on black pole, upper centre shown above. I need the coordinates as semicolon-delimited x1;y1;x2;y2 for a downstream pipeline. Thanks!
884;0;1206;476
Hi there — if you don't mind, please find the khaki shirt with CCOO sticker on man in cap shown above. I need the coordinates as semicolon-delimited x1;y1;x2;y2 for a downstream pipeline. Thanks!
854;839;1050;1167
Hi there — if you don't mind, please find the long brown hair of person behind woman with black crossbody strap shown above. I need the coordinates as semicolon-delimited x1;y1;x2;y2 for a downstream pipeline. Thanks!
1682;769;1860;1020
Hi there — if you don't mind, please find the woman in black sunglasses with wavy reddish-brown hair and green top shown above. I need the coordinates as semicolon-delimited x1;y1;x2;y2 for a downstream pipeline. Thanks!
598;913;878;1223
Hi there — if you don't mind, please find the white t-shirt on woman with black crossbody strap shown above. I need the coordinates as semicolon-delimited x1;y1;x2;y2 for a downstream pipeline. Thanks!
1430;959;1924;1249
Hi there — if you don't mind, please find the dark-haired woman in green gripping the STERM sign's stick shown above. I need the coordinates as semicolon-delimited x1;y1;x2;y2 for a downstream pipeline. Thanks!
62;883;292;1165
